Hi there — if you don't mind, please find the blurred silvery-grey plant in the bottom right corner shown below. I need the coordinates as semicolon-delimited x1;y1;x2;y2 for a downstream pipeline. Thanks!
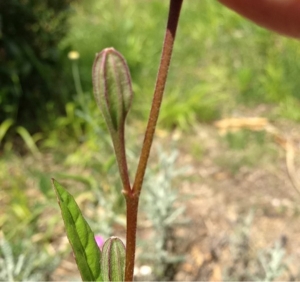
224;212;290;282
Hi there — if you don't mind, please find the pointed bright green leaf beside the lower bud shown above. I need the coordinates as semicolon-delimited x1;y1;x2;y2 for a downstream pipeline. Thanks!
52;179;103;281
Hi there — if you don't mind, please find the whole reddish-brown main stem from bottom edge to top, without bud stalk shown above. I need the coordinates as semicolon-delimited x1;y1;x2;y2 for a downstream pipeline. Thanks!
124;0;183;281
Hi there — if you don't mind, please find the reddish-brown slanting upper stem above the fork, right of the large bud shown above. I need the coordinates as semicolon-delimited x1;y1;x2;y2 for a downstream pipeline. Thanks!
132;0;183;194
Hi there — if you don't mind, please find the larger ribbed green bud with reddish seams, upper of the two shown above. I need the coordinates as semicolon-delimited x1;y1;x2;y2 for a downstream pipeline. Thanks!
92;48;132;132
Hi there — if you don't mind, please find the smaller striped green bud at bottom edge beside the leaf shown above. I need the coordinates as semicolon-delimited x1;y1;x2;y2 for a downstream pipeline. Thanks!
101;237;125;281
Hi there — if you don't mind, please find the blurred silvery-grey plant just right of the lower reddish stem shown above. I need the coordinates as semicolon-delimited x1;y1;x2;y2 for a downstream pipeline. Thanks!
139;148;188;281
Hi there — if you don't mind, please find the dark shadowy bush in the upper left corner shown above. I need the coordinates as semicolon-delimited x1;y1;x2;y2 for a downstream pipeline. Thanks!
0;0;71;132
